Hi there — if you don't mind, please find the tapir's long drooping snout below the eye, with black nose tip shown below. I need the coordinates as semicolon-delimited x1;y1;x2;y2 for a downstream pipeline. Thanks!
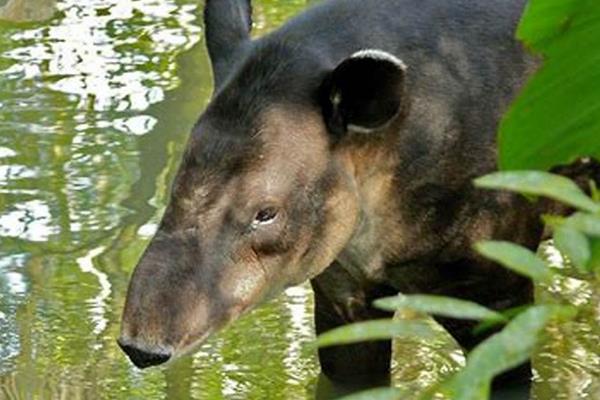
118;219;284;368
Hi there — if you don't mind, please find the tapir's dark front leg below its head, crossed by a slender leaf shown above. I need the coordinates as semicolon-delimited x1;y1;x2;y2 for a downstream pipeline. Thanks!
311;263;394;383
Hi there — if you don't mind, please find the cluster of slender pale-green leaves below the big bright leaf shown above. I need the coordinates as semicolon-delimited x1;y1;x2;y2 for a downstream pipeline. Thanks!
317;171;600;400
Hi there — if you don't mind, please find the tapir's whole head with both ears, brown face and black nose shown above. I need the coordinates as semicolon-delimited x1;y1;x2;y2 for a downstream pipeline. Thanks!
119;0;404;367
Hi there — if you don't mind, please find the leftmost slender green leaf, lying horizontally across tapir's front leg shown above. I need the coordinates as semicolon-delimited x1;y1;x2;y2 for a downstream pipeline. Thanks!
317;319;432;347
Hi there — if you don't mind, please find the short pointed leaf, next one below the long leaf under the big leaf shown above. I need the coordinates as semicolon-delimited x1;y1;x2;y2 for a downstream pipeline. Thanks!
475;241;554;283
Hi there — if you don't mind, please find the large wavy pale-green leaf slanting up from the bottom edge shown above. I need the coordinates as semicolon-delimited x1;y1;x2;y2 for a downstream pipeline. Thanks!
442;305;576;400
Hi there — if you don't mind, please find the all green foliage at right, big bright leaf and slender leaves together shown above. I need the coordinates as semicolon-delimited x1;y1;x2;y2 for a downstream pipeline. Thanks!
316;0;600;400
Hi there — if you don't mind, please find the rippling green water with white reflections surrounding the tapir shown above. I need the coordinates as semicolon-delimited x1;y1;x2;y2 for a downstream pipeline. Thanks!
0;0;600;400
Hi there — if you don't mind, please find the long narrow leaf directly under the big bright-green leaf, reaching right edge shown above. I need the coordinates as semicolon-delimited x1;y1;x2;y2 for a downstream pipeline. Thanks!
475;171;600;212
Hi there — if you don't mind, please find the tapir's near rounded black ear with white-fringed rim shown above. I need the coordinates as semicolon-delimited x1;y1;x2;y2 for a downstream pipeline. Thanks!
321;50;406;135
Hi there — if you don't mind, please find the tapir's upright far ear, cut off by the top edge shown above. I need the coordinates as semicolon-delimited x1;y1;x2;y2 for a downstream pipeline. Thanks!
204;0;252;86
